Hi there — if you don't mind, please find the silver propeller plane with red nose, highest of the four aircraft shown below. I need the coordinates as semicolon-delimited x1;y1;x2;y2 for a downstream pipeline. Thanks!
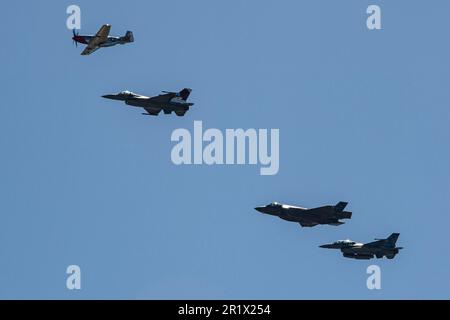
72;24;134;56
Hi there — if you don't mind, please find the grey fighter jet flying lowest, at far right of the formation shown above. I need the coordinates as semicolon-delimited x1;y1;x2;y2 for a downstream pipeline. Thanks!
320;233;403;260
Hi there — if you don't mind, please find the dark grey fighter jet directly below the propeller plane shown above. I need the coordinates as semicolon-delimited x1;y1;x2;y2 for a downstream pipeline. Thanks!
103;88;194;117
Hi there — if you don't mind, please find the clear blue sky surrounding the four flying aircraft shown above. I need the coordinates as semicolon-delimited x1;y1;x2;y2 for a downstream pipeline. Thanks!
0;0;450;299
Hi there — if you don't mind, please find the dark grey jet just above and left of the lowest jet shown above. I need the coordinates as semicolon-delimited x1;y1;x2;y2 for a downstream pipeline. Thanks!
255;202;352;227
